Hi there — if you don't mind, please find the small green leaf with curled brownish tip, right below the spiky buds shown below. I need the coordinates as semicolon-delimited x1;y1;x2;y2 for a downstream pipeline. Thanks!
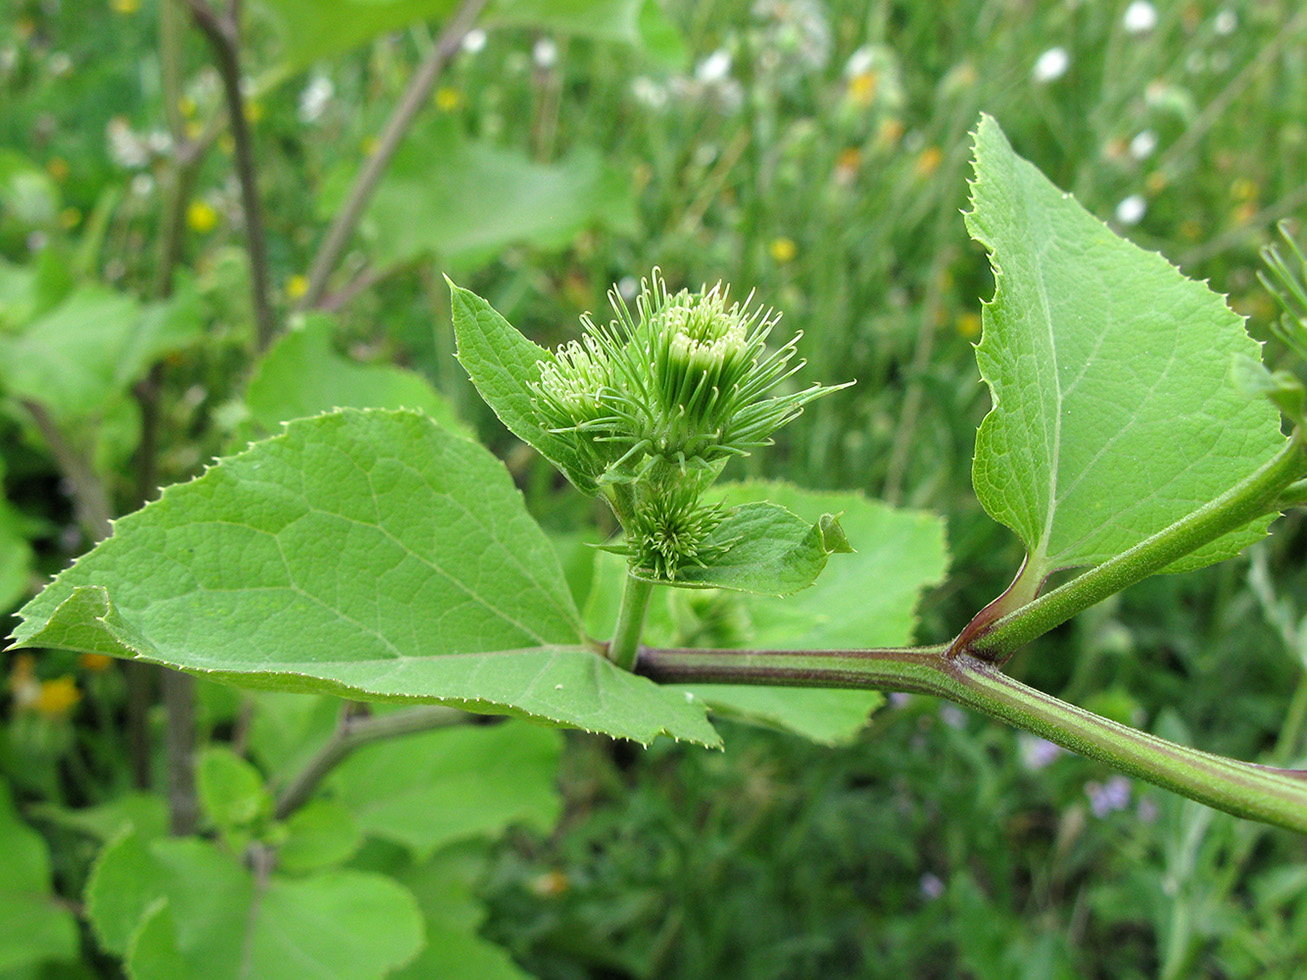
631;503;852;596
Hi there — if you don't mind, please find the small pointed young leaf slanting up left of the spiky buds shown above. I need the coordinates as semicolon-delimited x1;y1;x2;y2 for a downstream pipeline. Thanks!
450;282;596;495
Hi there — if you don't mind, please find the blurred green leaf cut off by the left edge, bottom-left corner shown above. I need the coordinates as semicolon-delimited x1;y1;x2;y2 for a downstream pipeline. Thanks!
0;783;77;971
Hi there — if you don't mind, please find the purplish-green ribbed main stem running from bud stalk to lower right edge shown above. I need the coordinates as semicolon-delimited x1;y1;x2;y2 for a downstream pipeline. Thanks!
639;647;1307;834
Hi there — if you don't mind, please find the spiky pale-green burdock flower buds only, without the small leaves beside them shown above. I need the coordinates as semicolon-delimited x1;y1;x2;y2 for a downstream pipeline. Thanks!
531;269;843;581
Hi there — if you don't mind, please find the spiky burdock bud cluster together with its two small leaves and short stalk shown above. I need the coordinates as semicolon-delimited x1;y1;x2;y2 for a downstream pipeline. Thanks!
459;269;848;662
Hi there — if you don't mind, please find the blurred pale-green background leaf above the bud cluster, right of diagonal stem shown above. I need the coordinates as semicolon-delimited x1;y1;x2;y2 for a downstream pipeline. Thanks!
367;124;637;273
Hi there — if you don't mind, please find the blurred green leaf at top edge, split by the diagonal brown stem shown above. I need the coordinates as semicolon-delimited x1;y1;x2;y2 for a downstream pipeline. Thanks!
263;0;681;76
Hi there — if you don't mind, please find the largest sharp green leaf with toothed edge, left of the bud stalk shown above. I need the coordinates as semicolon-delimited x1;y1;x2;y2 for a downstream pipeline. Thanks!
14;409;718;743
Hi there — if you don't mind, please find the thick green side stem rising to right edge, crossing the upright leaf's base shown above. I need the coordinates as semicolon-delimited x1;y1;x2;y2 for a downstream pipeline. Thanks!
953;433;1307;664
